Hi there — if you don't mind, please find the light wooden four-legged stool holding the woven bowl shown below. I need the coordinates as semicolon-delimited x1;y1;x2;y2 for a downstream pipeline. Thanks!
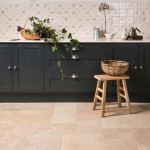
93;74;131;117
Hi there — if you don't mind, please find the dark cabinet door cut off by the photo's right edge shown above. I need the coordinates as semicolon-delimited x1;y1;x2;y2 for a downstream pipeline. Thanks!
139;43;150;102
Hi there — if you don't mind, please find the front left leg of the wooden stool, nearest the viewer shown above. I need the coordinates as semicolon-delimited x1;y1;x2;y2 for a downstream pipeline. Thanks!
101;80;107;117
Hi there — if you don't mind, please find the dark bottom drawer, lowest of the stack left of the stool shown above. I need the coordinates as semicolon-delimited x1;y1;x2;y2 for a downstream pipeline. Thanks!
45;75;96;92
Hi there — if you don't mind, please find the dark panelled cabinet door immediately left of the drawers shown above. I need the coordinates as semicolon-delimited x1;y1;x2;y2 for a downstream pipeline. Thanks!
13;43;44;92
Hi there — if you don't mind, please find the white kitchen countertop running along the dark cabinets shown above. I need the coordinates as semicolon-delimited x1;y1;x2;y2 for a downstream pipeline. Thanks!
0;38;150;43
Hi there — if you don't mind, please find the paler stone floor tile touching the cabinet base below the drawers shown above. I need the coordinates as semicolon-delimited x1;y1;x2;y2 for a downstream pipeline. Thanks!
52;103;77;123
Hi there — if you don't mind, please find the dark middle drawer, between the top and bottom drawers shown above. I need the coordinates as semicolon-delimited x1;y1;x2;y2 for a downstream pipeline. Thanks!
45;60;102;78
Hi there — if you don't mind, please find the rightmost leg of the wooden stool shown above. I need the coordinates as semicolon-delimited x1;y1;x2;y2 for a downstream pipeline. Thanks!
122;79;132;114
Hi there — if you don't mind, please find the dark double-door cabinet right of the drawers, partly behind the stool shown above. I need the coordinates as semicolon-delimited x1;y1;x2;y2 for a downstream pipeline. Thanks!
107;43;150;102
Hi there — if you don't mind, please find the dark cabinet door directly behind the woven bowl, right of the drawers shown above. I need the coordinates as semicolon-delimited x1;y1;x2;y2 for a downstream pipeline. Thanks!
107;43;139;93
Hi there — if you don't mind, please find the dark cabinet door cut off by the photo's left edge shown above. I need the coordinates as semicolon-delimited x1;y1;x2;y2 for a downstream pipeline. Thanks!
0;44;12;92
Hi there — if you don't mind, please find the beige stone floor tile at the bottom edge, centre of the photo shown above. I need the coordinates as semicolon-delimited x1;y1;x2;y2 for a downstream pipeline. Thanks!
61;133;106;150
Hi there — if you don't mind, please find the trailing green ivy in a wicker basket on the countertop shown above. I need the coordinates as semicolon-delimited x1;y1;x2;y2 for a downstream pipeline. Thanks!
17;16;81;80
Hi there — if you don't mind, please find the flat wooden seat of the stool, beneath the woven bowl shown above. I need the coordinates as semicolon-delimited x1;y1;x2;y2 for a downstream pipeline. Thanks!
94;74;129;80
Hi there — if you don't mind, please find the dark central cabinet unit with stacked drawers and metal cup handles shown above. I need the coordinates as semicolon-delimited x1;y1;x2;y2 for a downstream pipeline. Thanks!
45;43;106;92
